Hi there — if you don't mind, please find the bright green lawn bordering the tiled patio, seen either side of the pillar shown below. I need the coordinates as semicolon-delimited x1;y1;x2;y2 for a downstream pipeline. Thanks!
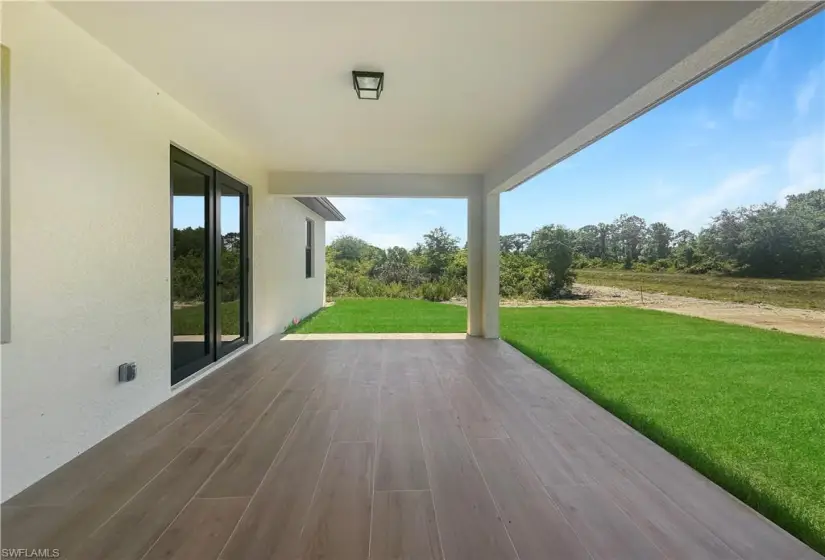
295;299;825;552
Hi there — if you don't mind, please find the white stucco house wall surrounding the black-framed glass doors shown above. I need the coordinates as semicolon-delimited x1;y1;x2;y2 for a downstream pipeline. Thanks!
2;2;324;500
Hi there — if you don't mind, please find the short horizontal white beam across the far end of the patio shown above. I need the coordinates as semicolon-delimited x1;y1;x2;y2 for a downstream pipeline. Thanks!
269;171;482;198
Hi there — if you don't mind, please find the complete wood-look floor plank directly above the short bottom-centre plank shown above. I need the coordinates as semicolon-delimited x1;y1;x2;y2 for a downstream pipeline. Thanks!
375;389;430;490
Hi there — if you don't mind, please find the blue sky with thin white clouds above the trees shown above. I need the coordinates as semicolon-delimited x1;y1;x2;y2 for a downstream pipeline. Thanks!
327;12;825;247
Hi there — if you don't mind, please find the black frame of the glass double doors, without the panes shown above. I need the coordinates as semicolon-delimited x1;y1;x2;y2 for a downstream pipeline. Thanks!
169;146;251;385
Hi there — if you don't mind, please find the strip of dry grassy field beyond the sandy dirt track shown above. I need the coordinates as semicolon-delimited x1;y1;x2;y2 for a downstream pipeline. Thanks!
576;268;825;310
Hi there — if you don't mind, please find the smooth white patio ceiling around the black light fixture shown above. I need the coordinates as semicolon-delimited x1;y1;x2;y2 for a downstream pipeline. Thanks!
56;2;788;179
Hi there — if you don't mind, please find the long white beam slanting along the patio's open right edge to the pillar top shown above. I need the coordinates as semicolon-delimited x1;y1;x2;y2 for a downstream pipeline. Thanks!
484;0;825;197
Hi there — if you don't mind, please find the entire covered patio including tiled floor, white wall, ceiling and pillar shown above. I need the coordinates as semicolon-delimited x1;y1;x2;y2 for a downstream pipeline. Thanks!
0;0;823;560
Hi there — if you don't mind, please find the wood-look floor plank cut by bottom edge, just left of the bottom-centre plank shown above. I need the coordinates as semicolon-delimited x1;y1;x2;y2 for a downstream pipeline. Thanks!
301;442;375;560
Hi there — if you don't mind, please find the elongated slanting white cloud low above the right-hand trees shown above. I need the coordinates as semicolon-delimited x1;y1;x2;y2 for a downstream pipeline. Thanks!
658;165;771;231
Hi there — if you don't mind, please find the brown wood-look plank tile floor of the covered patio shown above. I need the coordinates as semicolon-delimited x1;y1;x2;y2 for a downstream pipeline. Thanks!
2;334;819;560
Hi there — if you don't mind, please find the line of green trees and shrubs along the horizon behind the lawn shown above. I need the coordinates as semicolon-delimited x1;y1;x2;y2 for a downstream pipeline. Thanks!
326;189;825;301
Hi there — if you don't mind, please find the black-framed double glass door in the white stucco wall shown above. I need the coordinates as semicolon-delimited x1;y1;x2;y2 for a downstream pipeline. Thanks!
170;147;249;385
